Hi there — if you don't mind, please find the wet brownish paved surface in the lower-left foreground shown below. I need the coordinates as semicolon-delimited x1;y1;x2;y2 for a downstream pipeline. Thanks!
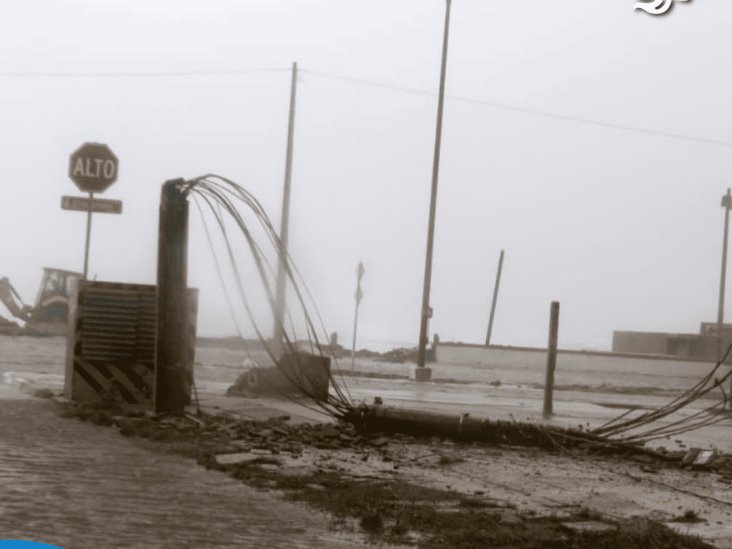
0;384;363;549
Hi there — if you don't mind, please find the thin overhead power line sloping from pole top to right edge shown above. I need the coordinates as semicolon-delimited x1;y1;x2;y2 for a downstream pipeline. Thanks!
300;69;732;147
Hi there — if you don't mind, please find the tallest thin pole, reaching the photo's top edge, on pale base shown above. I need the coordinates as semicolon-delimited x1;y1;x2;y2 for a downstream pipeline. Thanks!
415;0;452;380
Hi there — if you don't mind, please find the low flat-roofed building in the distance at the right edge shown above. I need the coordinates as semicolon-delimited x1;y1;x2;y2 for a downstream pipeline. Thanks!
612;322;732;362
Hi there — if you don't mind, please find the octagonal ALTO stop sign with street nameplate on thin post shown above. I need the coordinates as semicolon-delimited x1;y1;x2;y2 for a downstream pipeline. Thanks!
68;143;122;280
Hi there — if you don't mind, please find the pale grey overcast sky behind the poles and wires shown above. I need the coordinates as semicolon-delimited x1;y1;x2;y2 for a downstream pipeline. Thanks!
0;0;732;349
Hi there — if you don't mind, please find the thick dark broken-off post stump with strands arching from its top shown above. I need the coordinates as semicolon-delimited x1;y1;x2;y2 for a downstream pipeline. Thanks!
153;179;193;414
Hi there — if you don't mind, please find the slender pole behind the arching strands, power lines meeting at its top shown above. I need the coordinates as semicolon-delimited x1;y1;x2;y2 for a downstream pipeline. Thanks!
272;63;297;355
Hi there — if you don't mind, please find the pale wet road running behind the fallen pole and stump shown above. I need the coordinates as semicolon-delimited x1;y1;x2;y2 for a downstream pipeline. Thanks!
0;336;732;452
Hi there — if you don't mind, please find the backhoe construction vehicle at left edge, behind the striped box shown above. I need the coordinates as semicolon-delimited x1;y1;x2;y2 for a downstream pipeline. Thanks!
0;267;82;336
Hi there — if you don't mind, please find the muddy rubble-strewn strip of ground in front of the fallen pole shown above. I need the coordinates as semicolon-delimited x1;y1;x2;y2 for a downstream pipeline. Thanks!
59;403;712;549
